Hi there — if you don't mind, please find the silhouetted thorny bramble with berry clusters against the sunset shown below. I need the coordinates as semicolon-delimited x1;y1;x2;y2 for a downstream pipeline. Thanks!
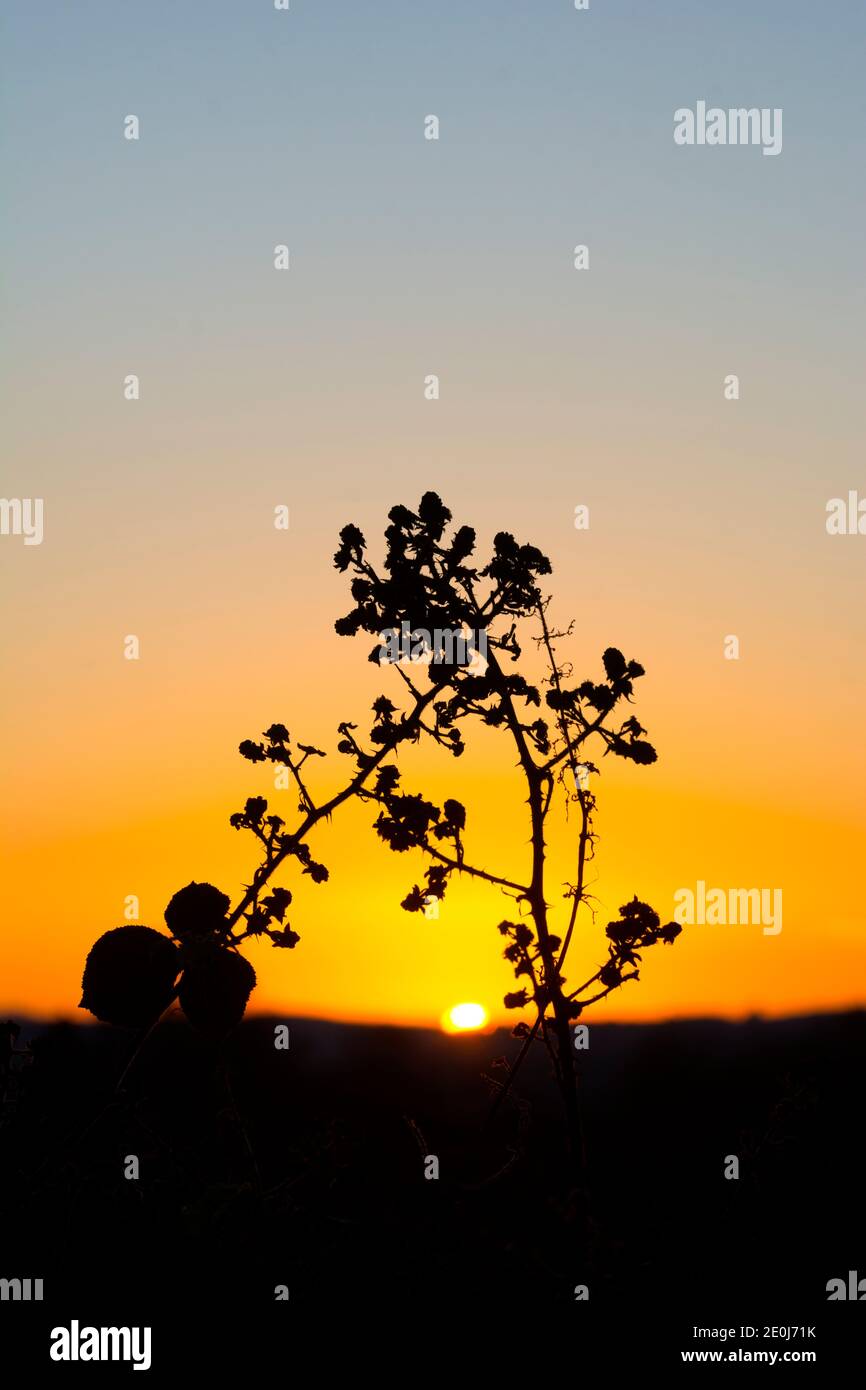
82;492;681;1159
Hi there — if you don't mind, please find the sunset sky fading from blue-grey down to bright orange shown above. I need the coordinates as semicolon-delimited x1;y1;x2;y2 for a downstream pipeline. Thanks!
0;0;866;1024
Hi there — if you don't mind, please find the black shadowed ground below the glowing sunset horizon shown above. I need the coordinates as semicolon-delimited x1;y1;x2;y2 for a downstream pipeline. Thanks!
0;1013;866;1372
